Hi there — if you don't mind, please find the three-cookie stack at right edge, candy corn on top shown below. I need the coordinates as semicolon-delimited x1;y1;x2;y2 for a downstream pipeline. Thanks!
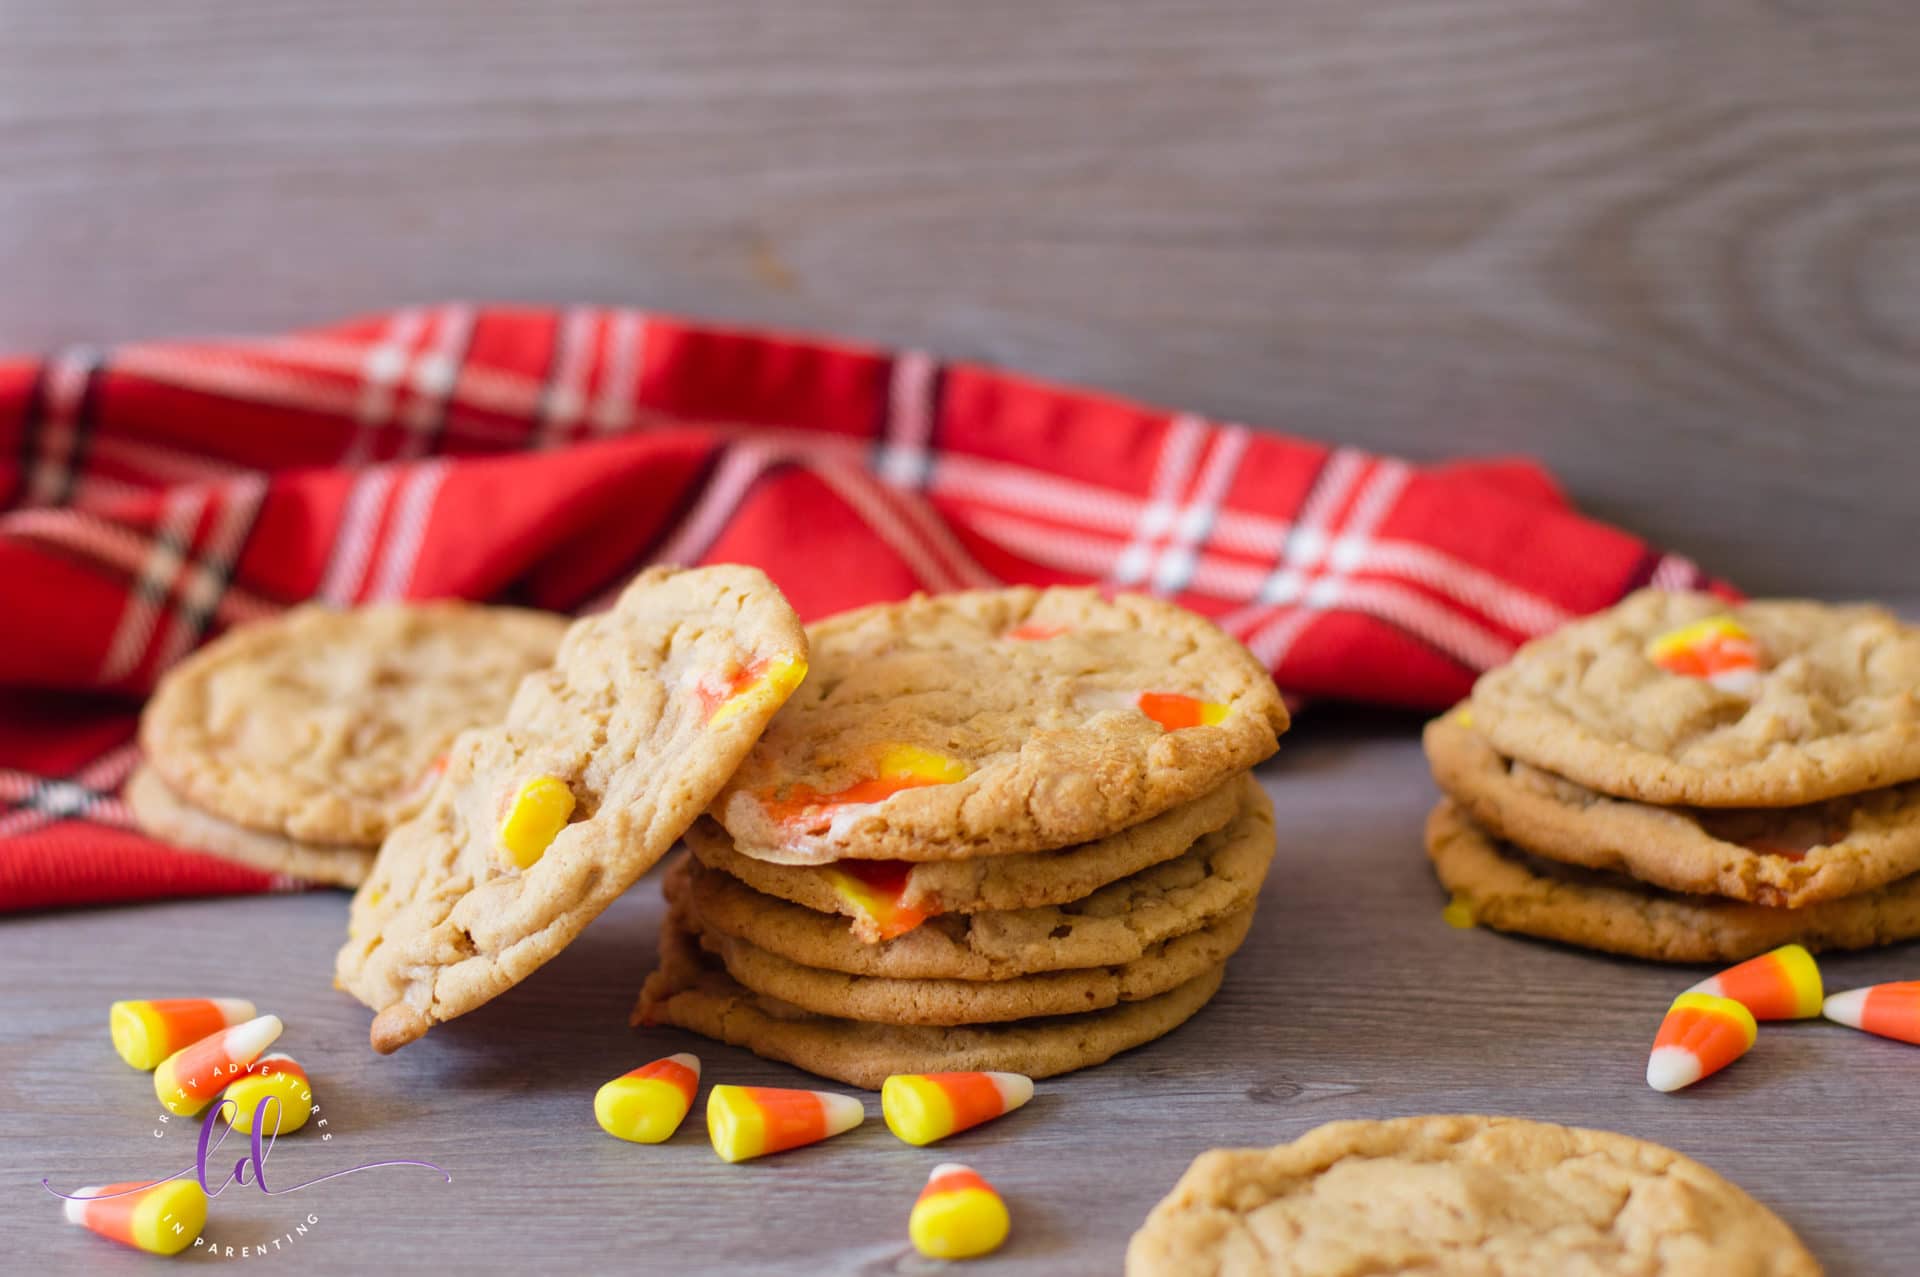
1427;591;1920;962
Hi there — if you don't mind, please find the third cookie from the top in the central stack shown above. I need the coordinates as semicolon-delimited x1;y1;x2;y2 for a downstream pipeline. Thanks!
666;785;1273;981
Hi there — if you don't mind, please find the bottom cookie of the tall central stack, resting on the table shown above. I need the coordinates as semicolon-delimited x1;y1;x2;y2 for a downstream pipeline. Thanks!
632;920;1225;1091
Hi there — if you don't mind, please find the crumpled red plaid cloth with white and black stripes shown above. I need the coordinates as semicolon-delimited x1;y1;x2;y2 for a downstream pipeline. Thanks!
0;305;1728;910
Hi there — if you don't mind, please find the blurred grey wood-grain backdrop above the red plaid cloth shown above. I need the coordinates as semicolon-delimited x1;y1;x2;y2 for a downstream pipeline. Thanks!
0;0;1920;593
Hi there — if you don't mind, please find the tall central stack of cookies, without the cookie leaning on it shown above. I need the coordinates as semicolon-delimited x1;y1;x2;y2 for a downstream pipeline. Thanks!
634;588;1286;1087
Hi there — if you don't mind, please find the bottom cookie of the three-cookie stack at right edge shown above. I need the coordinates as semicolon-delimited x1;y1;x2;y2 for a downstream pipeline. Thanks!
1427;799;1920;962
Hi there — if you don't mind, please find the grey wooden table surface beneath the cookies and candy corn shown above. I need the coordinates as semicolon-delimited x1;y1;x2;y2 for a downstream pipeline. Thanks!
0;711;1920;1275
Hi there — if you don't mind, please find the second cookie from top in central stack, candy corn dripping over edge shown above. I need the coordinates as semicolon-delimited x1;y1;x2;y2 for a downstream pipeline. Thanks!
687;776;1271;943
